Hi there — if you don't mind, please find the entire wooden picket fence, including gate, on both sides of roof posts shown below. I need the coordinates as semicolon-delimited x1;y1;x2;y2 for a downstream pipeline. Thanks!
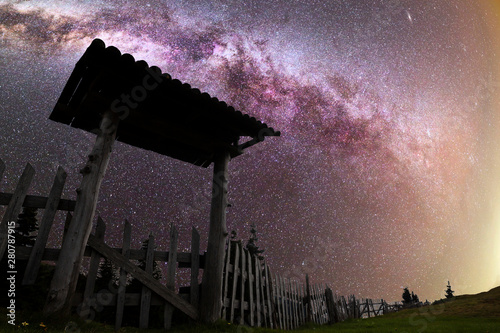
0;160;401;329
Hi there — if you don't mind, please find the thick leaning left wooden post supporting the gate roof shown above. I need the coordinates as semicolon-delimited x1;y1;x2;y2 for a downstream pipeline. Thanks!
44;111;118;315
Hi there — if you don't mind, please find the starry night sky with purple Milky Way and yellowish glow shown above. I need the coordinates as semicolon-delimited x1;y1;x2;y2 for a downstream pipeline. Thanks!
0;0;500;301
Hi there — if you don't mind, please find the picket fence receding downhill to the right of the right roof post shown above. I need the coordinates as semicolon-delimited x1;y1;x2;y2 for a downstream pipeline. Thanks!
222;241;399;329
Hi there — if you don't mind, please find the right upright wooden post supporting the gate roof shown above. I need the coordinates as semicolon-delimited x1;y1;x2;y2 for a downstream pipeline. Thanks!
200;151;230;323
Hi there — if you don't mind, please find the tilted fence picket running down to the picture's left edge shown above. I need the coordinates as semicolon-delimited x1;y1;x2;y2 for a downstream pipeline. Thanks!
0;163;35;259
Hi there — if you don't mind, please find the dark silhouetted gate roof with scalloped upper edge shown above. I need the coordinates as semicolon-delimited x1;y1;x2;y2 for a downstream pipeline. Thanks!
49;39;280;167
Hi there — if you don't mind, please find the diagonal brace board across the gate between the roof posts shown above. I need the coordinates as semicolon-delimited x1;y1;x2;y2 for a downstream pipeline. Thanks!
84;235;198;320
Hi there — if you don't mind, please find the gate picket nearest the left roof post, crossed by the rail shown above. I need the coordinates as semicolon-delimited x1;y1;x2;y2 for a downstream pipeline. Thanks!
78;216;106;320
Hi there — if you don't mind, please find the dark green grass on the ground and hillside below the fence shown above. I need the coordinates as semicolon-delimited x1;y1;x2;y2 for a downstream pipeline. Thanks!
0;287;500;333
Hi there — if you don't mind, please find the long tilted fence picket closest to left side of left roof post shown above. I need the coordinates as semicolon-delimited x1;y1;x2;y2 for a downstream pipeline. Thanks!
23;167;67;285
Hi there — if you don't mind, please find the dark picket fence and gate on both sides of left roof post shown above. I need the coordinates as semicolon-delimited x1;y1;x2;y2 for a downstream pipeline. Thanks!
0;160;199;328
